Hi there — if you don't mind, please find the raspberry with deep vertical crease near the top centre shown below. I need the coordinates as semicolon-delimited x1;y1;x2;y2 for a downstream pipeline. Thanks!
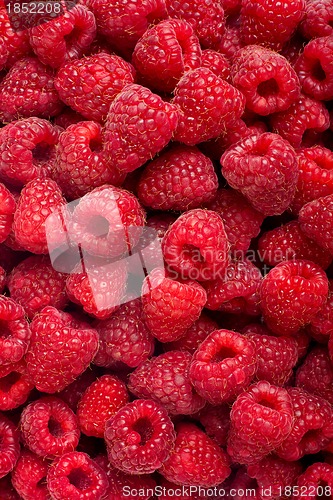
132;19;201;92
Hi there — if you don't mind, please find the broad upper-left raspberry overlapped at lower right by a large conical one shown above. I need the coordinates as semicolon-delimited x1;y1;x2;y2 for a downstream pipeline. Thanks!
54;51;135;121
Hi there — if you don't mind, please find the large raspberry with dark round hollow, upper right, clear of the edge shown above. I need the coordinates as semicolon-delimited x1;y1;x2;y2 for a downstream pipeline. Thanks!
232;45;300;116
